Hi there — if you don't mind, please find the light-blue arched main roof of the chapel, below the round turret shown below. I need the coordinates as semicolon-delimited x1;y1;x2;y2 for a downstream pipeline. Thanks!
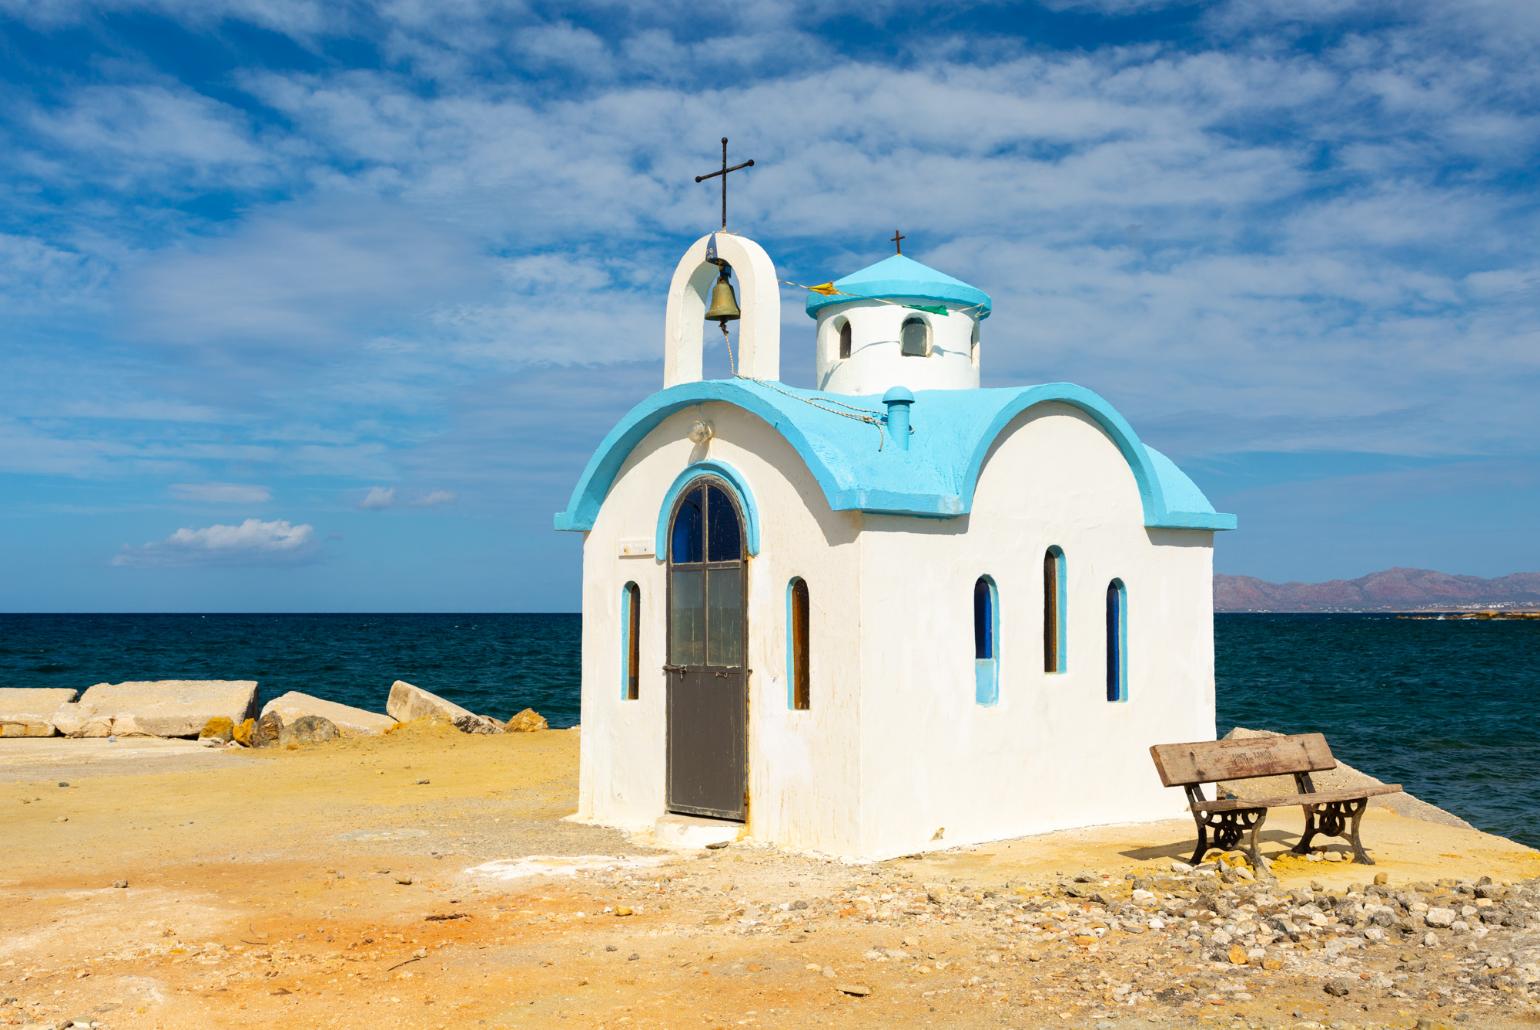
554;379;1237;531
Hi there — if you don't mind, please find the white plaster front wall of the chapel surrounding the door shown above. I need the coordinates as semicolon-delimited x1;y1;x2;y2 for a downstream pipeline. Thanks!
578;403;862;854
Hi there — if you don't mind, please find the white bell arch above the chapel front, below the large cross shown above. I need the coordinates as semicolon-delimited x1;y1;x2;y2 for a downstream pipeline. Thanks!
664;231;781;388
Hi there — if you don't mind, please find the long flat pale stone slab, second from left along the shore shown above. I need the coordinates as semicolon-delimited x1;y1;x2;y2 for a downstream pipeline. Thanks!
54;679;257;737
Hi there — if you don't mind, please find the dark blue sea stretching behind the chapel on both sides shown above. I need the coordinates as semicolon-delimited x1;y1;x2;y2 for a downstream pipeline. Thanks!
0;614;1540;847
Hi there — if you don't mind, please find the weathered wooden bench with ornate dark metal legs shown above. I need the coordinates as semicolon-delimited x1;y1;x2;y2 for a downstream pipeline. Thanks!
1150;733;1401;871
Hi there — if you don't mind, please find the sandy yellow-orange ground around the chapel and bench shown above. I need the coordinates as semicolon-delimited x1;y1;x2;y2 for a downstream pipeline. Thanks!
0;728;1540;1027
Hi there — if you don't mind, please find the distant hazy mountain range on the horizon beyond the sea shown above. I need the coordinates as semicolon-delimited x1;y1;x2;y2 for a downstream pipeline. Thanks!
1214;568;1540;611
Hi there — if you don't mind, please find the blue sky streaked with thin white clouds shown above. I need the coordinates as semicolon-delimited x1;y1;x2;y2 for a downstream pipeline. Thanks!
0;0;1540;611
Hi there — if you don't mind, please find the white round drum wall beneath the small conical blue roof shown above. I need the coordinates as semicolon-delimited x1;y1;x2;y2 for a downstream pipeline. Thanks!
815;300;983;394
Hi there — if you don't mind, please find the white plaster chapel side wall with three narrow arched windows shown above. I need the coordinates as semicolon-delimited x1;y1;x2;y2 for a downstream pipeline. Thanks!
856;400;1214;858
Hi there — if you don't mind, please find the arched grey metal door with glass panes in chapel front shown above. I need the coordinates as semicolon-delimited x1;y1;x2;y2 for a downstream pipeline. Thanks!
665;476;748;819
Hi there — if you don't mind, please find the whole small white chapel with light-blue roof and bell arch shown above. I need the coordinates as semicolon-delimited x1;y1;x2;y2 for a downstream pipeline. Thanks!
556;223;1235;859
